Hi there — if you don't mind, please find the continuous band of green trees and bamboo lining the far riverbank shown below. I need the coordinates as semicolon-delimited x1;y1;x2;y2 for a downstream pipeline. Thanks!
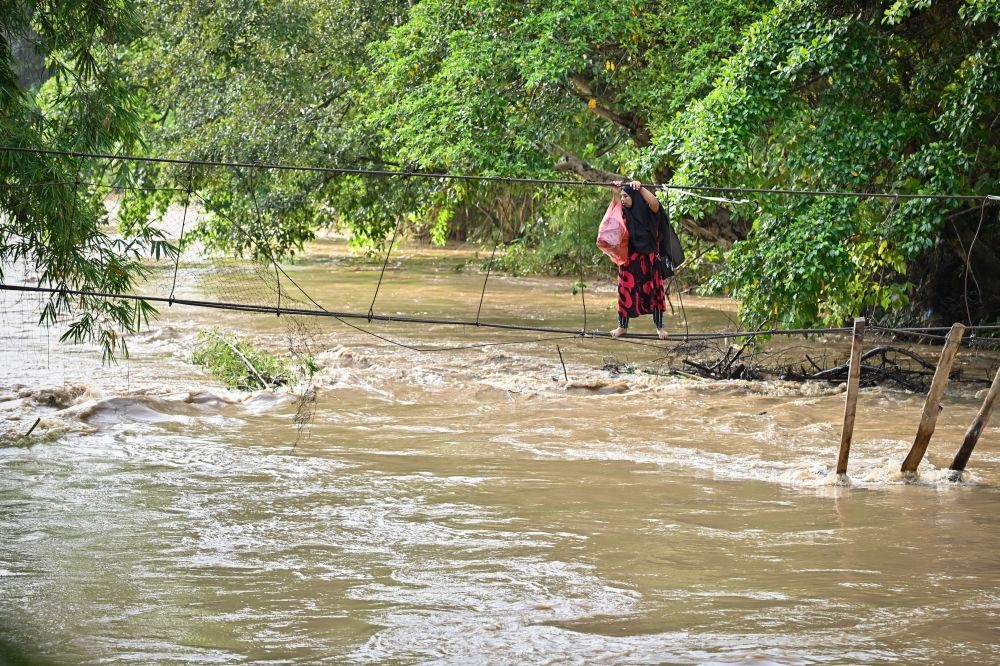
0;0;1000;356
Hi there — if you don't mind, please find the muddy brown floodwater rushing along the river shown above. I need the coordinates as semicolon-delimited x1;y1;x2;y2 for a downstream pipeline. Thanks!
0;240;1000;664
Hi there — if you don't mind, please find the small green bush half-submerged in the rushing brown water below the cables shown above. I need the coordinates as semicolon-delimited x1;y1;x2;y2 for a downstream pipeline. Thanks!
193;331;288;391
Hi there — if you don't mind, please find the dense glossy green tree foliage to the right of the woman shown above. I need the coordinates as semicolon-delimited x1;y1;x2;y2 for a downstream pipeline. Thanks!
660;0;1000;326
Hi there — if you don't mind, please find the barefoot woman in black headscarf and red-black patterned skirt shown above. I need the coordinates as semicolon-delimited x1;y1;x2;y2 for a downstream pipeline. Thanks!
611;180;667;340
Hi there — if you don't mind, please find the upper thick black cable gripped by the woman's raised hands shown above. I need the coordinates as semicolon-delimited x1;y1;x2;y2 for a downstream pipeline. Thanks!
0;146;1000;201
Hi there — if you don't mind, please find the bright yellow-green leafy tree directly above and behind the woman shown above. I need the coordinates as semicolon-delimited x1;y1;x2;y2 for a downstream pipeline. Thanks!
360;0;772;265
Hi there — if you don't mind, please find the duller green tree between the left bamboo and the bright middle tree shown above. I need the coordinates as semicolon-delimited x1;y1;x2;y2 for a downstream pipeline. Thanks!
121;0;407;258
